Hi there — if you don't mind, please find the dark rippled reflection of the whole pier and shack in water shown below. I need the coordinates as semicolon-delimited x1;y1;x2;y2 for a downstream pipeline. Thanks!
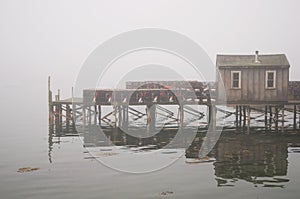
49;125;300;188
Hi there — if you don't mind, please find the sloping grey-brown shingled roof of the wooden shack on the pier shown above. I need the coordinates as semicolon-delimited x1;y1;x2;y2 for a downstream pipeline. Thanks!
217;54;290;67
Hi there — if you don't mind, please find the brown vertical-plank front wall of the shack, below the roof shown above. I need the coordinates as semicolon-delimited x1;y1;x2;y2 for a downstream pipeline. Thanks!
218;66;289;103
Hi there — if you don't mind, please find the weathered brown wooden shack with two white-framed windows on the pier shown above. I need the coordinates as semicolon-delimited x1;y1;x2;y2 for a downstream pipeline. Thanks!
216;51;290;104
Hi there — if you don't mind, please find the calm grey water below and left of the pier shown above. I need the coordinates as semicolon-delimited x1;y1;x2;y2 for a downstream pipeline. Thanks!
0;86;300;199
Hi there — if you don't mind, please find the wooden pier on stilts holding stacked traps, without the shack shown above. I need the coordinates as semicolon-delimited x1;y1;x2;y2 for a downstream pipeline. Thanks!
48;77;300;134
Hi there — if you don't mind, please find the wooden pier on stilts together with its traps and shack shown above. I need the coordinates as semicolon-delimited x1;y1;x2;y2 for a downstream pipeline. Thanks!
48;51;300;133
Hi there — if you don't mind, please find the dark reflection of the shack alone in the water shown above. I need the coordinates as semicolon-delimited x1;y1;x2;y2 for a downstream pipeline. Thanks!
214;135;288;186
